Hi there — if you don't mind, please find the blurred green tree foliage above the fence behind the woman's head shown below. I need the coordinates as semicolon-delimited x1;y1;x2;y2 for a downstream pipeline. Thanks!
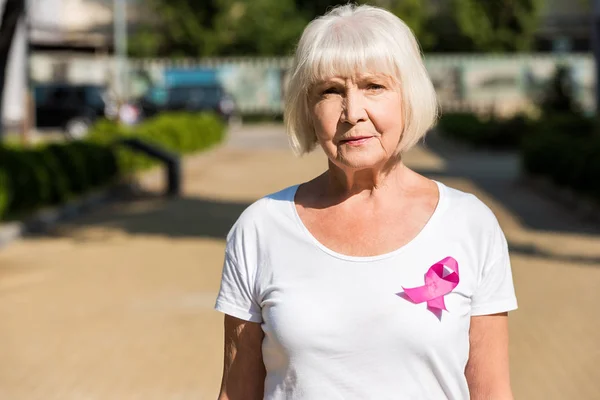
129;0;542;57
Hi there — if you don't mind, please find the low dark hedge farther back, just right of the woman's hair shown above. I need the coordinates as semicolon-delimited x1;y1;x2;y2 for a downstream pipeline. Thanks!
438;113;533;149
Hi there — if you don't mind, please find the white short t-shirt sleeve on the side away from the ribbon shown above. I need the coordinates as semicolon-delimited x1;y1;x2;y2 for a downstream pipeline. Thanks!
215;252;262;322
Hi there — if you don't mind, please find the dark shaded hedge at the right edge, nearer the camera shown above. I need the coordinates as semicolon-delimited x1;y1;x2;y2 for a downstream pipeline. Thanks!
521;115;600;200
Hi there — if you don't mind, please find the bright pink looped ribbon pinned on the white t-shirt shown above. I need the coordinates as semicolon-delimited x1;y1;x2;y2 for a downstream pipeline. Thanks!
402;257;459;311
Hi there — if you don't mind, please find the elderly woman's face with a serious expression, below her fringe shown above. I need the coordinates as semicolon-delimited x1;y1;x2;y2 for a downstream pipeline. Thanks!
309;74;404;169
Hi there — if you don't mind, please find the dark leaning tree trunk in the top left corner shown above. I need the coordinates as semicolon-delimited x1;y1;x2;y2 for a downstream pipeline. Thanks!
0;0;25;143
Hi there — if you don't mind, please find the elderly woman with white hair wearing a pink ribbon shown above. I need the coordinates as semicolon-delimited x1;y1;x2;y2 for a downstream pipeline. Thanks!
215;5;517;400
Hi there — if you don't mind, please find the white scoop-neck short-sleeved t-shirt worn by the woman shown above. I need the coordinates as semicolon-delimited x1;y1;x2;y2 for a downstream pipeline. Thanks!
215;182;517;400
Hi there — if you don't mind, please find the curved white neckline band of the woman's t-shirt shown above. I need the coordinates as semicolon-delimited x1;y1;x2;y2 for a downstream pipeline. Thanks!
287;180;446;262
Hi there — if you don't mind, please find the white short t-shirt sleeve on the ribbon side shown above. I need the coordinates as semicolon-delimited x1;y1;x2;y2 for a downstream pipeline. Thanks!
471;226;518;316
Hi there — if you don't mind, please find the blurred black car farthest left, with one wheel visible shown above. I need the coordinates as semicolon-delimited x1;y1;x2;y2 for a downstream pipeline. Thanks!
35;83;115;138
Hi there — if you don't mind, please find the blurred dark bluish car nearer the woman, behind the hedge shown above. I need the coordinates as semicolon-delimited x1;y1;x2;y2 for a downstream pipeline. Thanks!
139;85;237;122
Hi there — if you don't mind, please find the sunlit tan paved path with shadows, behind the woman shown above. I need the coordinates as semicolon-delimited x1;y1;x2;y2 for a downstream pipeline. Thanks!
0;125;600;400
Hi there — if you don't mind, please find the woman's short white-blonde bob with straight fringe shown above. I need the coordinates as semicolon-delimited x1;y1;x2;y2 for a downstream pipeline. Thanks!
284;4;438;155
